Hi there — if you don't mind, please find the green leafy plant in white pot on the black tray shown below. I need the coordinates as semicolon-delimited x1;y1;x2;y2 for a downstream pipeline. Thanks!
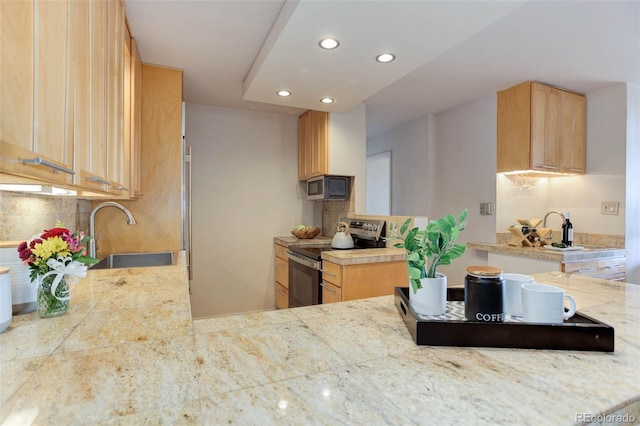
389;209;469;315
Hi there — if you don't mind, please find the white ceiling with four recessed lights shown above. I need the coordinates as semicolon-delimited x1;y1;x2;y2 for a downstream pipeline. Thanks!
125;0;640;136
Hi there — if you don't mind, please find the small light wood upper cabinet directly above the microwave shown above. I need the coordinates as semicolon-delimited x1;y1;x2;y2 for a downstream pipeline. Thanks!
298;110;329;180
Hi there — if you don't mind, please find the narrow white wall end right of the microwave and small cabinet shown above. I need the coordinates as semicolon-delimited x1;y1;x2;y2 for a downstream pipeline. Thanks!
329;104;367;213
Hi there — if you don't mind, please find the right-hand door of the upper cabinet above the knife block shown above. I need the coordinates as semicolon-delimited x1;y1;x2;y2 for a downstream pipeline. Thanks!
559;90;587;173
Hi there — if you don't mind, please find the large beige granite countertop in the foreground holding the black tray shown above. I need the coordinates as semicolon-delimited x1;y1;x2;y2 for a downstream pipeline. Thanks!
0;255;640;425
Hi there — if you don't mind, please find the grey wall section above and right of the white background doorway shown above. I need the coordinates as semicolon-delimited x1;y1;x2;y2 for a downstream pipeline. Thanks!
367;116;434;216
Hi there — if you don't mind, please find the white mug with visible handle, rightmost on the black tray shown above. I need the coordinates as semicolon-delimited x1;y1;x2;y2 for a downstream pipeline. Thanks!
522;283;576;324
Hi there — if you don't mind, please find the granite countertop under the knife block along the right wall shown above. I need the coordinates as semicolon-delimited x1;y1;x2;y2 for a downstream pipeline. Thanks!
467;242;627;263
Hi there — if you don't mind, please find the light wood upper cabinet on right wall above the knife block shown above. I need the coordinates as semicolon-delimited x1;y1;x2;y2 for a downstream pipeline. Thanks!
497;81;586;174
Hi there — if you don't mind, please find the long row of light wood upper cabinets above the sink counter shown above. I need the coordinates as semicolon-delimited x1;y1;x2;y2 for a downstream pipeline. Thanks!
0;0;135;198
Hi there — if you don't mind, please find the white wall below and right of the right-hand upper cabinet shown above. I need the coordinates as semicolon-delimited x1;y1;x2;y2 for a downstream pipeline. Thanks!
496;84;627;235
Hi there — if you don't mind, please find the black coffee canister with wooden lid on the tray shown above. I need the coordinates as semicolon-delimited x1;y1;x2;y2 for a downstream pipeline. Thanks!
464;266;504;322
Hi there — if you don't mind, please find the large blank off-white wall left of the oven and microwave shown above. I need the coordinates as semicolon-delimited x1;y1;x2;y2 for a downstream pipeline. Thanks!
186;104;316;317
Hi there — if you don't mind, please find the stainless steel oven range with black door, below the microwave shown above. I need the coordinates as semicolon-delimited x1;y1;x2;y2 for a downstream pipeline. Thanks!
287;218;386;308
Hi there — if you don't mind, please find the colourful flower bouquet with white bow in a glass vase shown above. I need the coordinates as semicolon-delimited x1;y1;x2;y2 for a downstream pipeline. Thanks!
18;223;98;316
